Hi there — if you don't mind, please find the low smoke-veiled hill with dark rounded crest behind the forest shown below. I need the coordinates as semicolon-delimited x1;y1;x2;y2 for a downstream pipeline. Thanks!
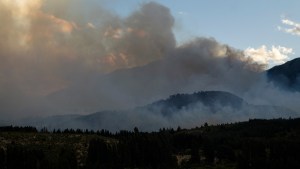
23;91;295;131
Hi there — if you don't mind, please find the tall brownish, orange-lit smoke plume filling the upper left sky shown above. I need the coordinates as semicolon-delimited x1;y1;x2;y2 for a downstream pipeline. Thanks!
0;0;175;118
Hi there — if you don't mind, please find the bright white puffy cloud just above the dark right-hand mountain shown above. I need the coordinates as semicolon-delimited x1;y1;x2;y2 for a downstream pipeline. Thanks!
244;45;294;65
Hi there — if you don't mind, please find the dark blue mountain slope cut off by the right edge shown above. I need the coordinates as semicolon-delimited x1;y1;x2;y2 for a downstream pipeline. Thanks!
267;58;300;92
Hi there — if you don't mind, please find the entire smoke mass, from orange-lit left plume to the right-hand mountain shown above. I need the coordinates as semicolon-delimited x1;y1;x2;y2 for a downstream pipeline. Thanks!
0;0;300;126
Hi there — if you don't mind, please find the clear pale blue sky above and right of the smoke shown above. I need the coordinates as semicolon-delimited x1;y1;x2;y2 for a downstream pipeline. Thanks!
105;0;300;67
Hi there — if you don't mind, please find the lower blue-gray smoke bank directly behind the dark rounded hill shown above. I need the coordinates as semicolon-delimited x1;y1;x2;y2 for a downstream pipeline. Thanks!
48;38;262;112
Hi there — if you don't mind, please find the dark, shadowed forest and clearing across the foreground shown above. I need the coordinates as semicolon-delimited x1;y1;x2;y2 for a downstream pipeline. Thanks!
0;118;300;169
